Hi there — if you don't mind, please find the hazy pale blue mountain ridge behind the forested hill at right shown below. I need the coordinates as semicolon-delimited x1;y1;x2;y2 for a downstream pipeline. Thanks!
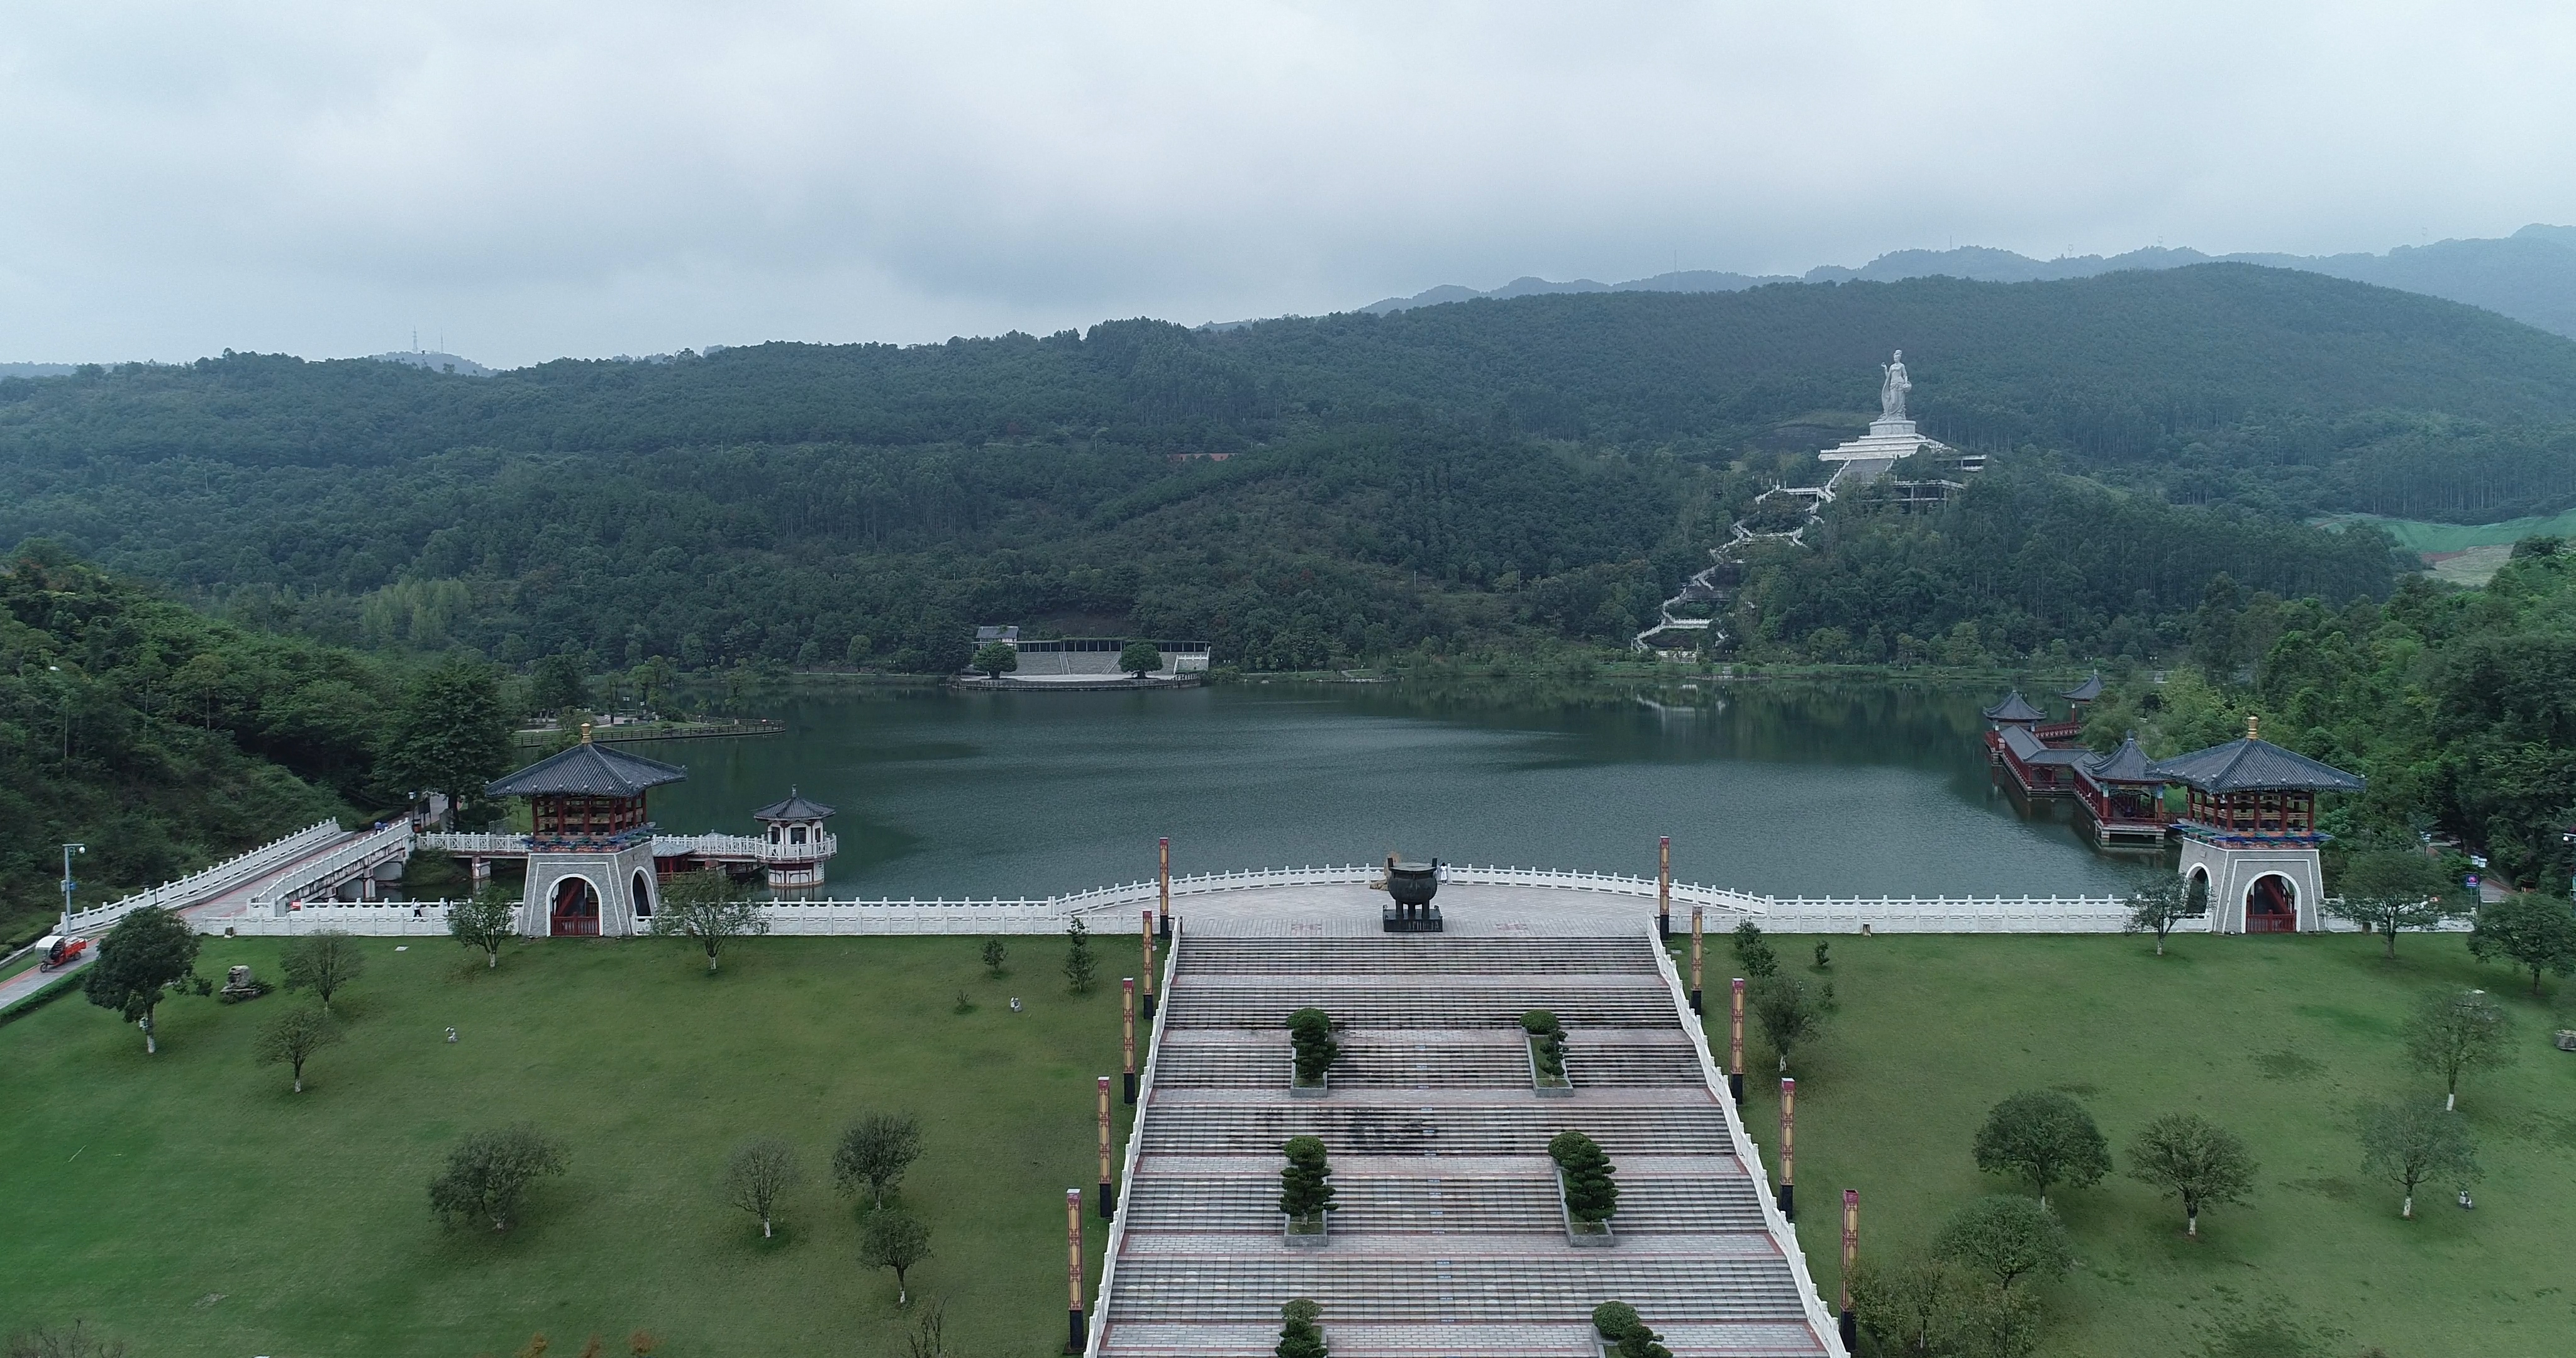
1360;221;2576;338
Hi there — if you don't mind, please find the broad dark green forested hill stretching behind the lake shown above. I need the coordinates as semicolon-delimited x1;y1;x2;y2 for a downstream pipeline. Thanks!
0;265;2576;668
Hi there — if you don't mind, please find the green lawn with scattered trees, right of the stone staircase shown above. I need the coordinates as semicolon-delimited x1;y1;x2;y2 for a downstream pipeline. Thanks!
1711;936;2576;1358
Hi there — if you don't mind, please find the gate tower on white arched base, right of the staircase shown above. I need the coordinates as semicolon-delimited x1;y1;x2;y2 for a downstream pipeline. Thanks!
2148;716;2365;933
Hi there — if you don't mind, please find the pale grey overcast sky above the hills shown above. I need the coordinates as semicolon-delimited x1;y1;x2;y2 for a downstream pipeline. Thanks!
0;0;2576;366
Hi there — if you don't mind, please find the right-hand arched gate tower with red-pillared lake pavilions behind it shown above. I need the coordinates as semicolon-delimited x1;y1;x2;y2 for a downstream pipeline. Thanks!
1984;675;2365;933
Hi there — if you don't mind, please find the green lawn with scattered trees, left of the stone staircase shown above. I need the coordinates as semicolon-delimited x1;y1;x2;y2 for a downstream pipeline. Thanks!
0;938;1133;1358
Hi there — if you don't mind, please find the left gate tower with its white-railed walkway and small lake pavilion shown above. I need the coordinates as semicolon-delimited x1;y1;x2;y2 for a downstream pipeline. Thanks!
418;724;840;938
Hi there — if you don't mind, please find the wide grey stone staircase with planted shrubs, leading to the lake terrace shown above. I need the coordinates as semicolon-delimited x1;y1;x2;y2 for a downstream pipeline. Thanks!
1095;928;1840;1358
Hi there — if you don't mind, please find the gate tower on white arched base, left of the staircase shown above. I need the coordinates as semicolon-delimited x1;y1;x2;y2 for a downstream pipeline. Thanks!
484;722;688;938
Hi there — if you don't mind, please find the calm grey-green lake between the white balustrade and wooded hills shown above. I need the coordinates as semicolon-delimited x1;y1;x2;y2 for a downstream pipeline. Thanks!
639;683;2141;897
